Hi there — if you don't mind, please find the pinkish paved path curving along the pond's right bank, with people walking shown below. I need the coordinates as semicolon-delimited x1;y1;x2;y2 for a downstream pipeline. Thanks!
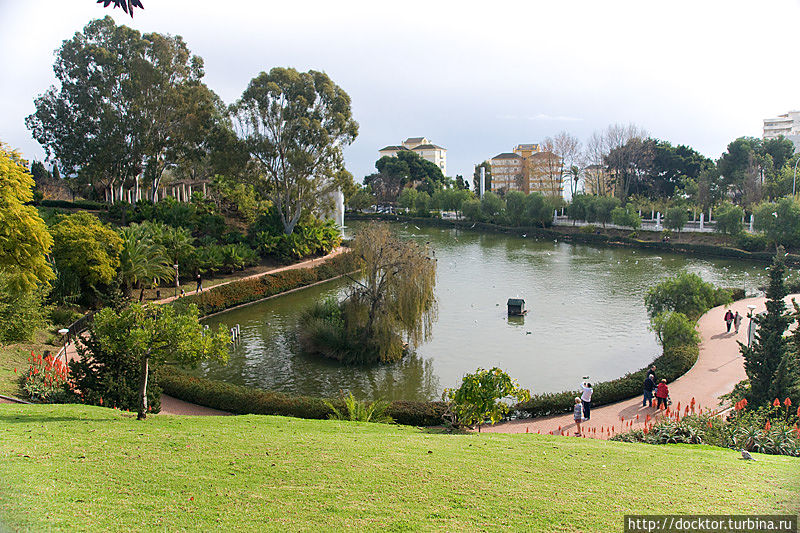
481;294;800;439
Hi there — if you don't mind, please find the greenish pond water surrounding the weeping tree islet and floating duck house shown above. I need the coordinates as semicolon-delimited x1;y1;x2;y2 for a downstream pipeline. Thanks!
198;223;766;400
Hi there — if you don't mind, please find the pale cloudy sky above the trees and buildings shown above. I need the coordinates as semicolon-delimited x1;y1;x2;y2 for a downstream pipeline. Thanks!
0;0;800;179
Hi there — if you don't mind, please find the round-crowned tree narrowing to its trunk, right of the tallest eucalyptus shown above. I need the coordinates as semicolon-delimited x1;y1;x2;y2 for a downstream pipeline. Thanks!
232;67;358;235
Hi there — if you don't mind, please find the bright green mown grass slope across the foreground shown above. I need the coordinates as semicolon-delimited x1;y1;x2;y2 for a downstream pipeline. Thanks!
0;405;800;531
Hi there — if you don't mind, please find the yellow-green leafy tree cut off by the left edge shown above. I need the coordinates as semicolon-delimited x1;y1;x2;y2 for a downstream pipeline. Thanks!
0;142;54;292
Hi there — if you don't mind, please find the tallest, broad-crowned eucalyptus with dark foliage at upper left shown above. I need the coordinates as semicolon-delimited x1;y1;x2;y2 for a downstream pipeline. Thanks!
26;16;216;202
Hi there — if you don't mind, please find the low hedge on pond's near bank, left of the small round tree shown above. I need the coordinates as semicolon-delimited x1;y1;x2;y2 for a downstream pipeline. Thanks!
153;367;447;426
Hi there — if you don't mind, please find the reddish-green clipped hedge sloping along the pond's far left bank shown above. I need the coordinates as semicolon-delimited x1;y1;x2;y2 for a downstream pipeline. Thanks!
172;252;355;316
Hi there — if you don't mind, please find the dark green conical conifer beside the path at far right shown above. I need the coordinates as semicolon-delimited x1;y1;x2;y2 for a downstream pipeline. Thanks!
739;247;792;407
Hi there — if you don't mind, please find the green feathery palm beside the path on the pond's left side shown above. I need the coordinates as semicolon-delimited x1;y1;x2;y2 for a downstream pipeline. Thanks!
119;224;174;302
